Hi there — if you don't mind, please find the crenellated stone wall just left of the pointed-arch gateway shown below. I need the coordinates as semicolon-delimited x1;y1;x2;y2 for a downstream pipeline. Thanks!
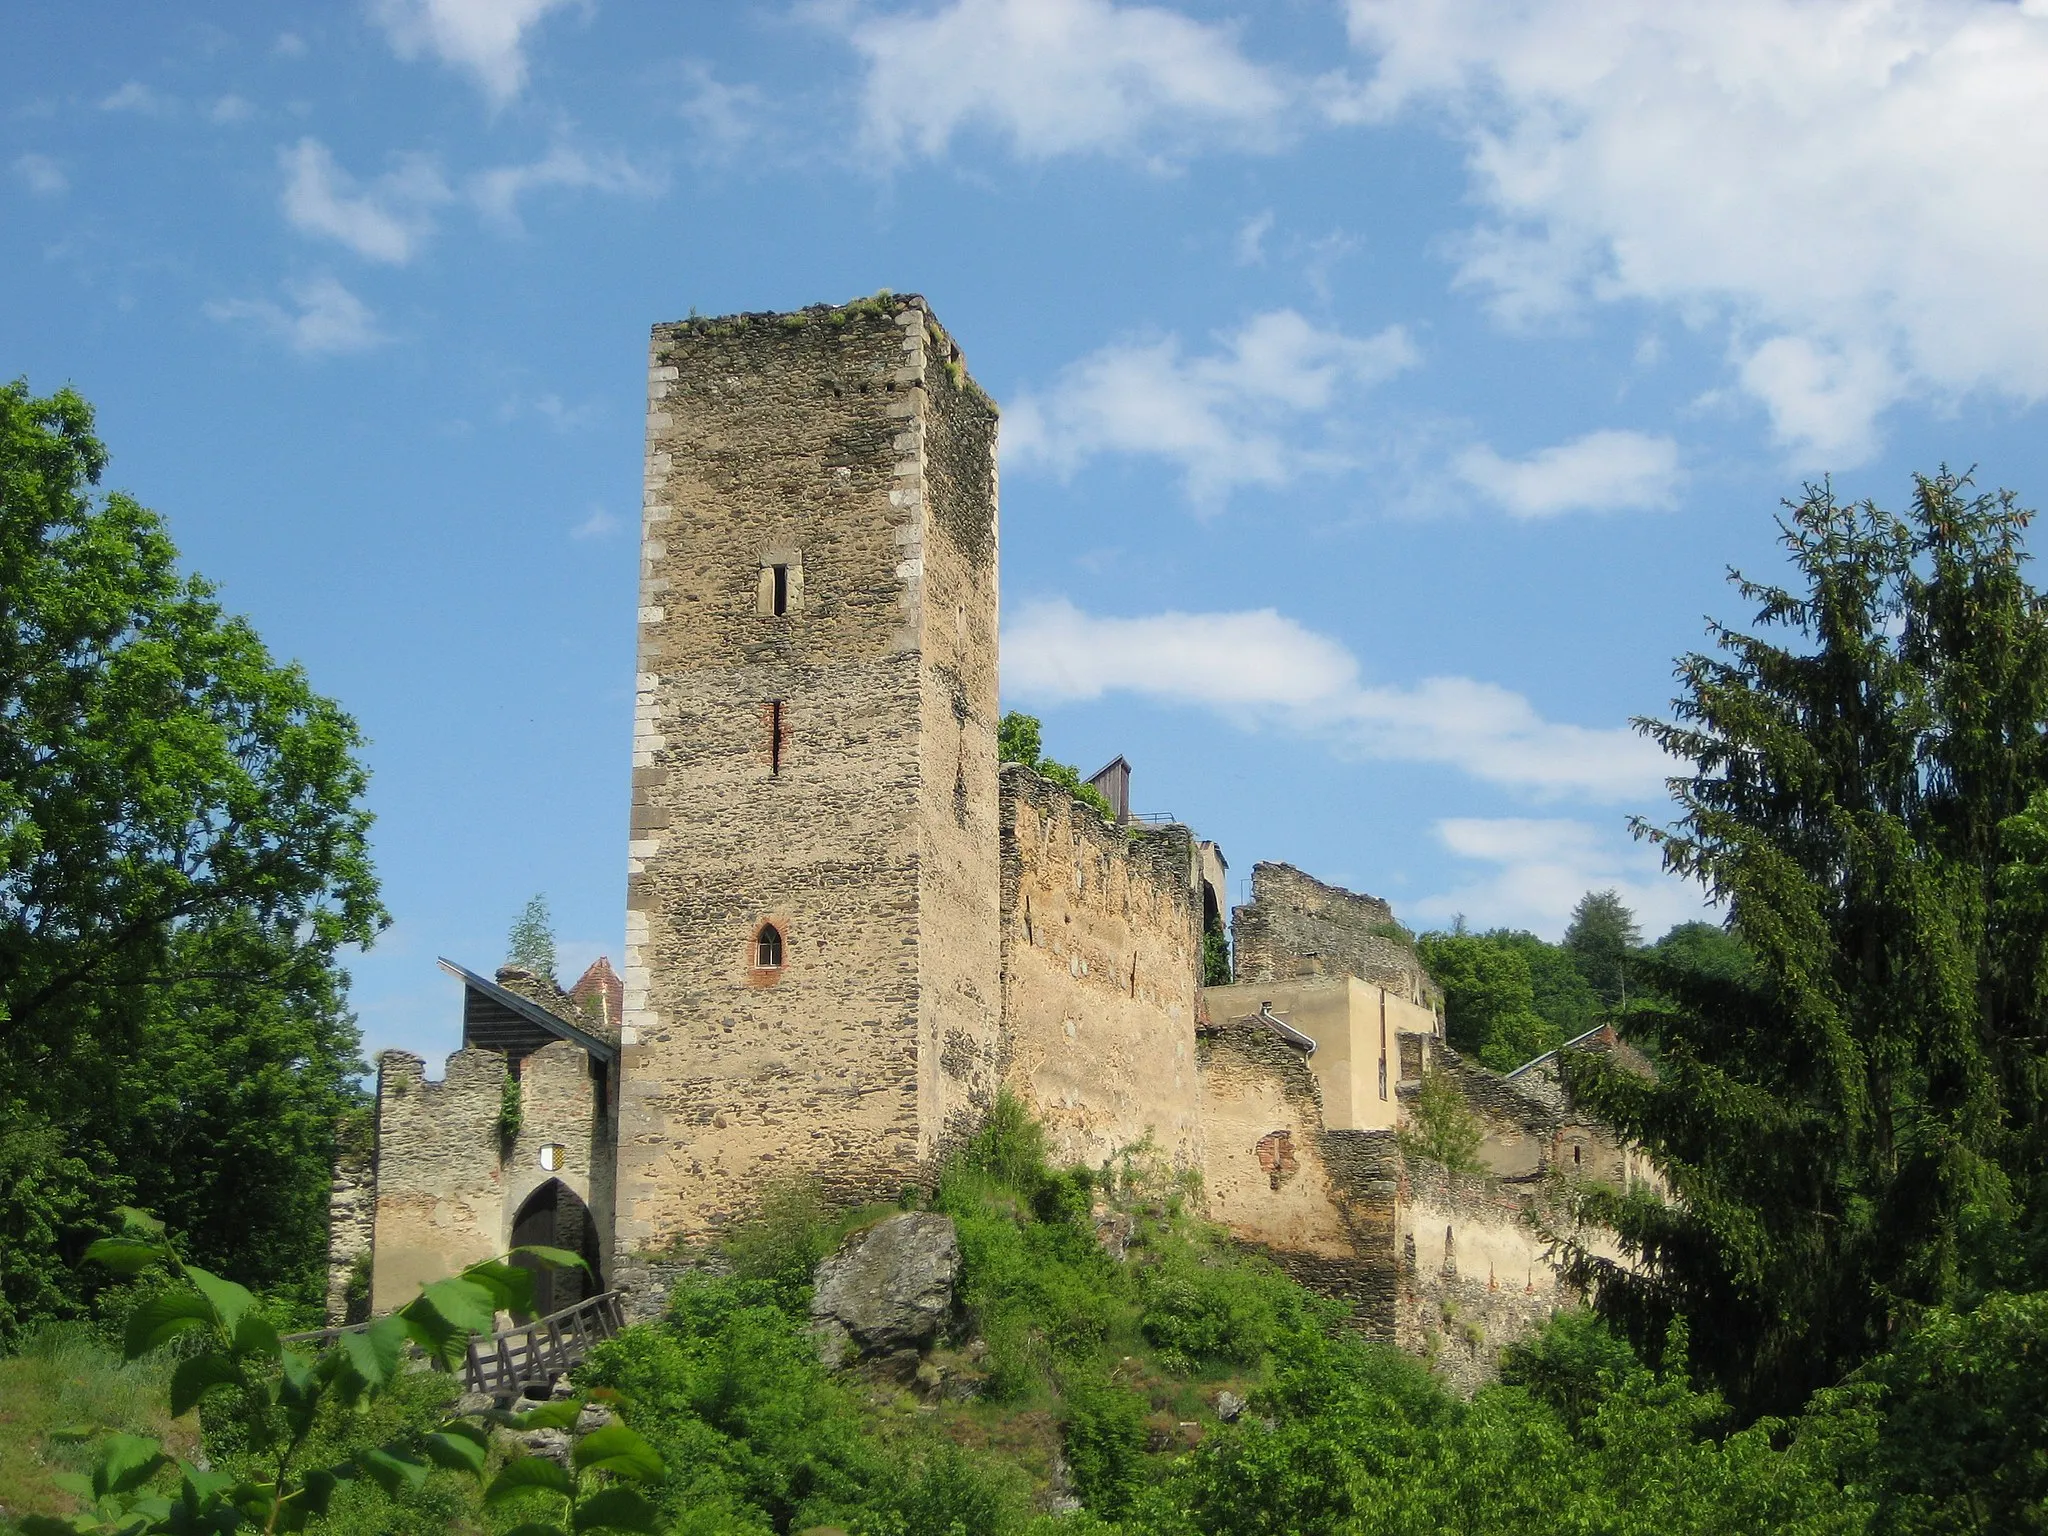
371;1051;506;1313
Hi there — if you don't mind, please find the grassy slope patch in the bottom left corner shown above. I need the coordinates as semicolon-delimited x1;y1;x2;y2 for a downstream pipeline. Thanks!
0;1323;199;1518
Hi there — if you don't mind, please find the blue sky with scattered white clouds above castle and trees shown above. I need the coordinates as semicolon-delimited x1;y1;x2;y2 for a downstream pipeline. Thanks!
0;0;2048;1053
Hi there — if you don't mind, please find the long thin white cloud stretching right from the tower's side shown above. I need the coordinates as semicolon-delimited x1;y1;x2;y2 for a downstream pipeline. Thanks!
1004;600;1667;801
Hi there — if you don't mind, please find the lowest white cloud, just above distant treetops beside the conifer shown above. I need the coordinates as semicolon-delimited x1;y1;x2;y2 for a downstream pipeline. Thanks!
1415;817;1714;940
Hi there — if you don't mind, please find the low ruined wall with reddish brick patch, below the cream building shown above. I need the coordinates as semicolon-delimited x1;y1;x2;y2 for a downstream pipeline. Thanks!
1200;1022;1401;1341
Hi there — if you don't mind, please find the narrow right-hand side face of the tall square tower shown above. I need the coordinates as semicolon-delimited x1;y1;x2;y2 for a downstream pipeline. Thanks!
917;311;1001;1161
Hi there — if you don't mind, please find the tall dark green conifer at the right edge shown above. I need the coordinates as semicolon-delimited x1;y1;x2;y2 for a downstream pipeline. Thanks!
1569;471;2048;1413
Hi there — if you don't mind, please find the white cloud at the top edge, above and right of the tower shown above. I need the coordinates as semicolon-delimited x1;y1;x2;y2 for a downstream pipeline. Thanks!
848;0;1290;160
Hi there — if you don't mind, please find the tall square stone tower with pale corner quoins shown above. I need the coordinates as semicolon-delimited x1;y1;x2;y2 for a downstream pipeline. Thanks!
618;297;1001;1251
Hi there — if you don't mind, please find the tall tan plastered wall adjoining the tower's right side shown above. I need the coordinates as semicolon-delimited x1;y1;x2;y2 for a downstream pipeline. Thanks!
1001;764;1202;1169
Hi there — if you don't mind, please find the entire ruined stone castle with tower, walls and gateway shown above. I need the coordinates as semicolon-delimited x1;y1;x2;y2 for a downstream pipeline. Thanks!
332;297;1634;1376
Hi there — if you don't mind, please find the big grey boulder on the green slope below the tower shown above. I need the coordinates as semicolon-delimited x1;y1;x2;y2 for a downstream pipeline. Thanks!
811;1210;961;1370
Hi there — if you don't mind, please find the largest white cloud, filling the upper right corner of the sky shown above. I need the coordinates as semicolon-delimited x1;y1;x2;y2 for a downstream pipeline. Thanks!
1348;0;2048;465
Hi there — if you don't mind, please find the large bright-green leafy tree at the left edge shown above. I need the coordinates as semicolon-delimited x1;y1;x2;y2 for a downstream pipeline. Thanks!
0;381;385;1335
